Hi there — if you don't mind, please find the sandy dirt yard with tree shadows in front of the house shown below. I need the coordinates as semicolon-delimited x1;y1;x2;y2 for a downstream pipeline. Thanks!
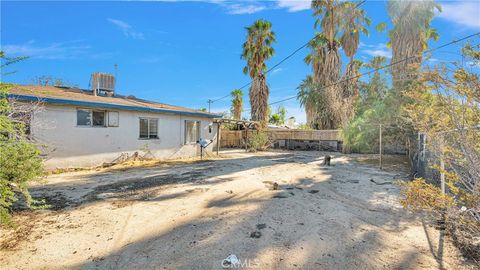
0;151;471;269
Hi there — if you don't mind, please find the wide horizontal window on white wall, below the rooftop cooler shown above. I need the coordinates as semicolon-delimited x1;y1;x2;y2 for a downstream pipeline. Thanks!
77;109;119;127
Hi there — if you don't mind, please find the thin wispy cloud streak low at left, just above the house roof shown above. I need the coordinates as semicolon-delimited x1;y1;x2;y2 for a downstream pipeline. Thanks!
2;40;91;60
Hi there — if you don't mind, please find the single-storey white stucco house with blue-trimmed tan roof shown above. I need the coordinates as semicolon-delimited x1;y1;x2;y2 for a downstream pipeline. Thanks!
9;85;219;169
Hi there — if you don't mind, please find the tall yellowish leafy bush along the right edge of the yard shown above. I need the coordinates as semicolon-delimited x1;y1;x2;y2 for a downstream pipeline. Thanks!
403;44;480;263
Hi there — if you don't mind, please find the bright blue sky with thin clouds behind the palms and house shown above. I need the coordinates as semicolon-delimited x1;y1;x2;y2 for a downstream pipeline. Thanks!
0;0;480;122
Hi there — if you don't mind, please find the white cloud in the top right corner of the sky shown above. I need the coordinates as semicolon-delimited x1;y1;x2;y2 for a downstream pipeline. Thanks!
438;1;480;29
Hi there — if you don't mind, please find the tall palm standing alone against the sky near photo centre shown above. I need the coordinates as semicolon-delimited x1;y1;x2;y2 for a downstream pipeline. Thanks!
241;20;275;125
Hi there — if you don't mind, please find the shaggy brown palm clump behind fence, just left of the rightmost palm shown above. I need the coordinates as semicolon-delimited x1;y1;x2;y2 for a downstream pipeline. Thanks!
305;0;370;128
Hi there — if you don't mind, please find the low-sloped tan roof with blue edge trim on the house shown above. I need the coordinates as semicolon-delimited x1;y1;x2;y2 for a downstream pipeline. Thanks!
9;85;220;118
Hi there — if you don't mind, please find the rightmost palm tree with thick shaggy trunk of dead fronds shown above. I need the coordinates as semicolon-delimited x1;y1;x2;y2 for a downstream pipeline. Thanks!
387;0;441;94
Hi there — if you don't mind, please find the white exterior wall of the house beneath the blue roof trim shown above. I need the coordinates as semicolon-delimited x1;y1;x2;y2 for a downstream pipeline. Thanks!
32;104;217;169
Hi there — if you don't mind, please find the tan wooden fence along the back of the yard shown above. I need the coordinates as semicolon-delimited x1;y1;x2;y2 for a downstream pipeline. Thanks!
220;129;342;147
